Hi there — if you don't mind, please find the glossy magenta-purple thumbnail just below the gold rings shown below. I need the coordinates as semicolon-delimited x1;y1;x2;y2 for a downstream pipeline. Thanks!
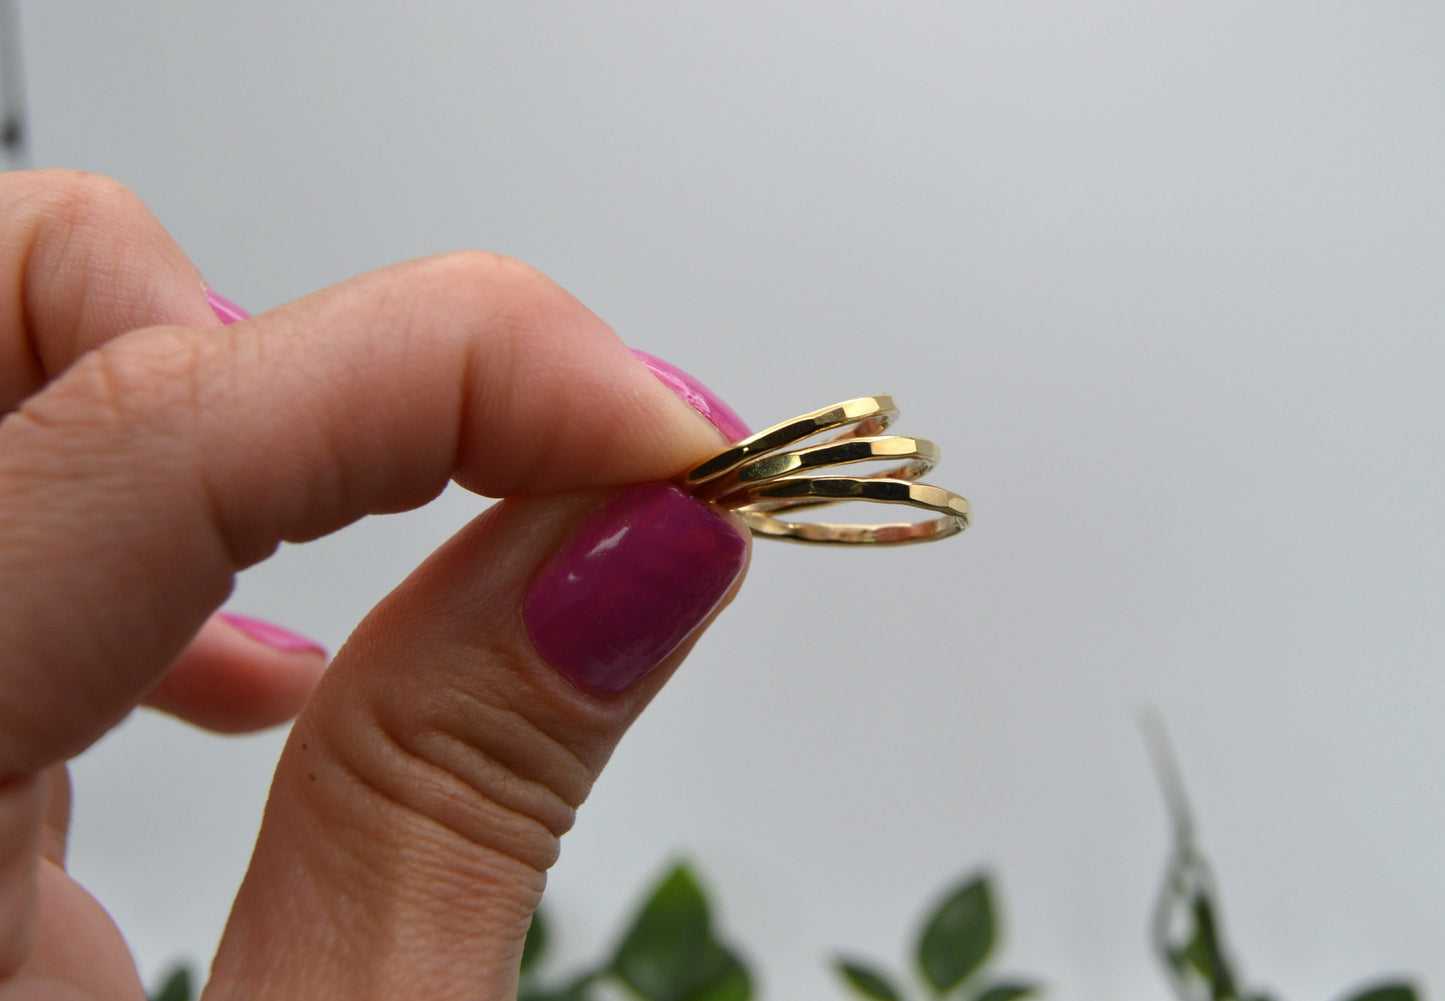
522;484;747;696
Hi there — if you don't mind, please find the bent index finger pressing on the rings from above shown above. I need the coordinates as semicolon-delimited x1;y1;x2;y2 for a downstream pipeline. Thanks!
0;253;723;777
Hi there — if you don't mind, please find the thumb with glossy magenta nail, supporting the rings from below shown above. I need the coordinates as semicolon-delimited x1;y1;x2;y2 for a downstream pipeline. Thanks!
205;484;749;1001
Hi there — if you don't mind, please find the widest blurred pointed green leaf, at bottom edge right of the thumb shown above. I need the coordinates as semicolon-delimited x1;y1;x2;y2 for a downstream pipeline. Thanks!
610;865;751;1001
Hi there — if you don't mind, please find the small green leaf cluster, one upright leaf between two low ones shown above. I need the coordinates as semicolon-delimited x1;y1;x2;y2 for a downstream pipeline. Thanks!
834;874;1038;1001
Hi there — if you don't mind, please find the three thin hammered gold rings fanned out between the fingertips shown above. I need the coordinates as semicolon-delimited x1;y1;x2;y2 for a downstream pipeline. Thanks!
682;396;968;545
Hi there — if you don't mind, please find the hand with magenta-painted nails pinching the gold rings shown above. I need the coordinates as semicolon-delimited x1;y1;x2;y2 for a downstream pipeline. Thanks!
0;172;749;1001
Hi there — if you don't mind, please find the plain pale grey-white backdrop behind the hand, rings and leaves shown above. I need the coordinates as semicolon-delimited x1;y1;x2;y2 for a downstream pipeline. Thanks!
14;7;1445;1001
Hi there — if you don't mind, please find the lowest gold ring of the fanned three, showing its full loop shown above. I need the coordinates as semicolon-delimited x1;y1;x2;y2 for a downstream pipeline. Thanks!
734;477;971;545
